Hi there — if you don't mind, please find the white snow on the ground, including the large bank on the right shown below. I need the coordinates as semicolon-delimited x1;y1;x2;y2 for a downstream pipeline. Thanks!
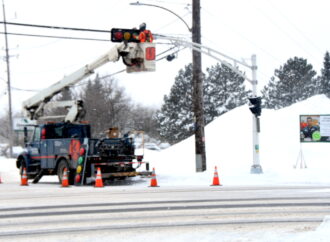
0;95;330;242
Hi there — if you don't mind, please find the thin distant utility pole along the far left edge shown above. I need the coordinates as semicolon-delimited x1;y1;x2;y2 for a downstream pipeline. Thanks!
2;0;14;157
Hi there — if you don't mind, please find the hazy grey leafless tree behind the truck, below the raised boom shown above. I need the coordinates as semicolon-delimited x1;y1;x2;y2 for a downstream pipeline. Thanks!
80;76;159;138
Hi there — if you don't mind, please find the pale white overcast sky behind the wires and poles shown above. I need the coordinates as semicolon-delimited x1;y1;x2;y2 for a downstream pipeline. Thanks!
0;0;330;116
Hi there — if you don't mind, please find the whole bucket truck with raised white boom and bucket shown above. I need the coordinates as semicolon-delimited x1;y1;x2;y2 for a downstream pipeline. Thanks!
16;42;155;185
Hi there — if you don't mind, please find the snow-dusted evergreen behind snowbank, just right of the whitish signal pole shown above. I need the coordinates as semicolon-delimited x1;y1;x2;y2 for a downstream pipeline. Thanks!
261;57;317;109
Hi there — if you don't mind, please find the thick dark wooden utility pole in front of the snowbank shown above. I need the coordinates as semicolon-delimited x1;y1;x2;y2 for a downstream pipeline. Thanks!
192;0;206;172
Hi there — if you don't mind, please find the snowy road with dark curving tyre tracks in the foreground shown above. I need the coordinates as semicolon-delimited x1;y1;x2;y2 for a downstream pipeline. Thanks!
0;184;330;241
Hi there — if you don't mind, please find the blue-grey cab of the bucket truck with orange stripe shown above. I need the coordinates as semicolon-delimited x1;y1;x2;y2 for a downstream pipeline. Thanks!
16;122;91;182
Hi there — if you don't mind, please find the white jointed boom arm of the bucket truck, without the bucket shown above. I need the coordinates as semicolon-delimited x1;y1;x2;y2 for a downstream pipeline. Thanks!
23;43;137;122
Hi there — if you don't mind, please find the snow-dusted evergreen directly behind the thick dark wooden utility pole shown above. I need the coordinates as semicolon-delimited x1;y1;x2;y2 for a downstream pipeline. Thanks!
156;64;249;144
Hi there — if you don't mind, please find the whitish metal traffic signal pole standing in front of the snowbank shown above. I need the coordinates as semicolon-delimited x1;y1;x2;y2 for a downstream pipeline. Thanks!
251;55;262;174
